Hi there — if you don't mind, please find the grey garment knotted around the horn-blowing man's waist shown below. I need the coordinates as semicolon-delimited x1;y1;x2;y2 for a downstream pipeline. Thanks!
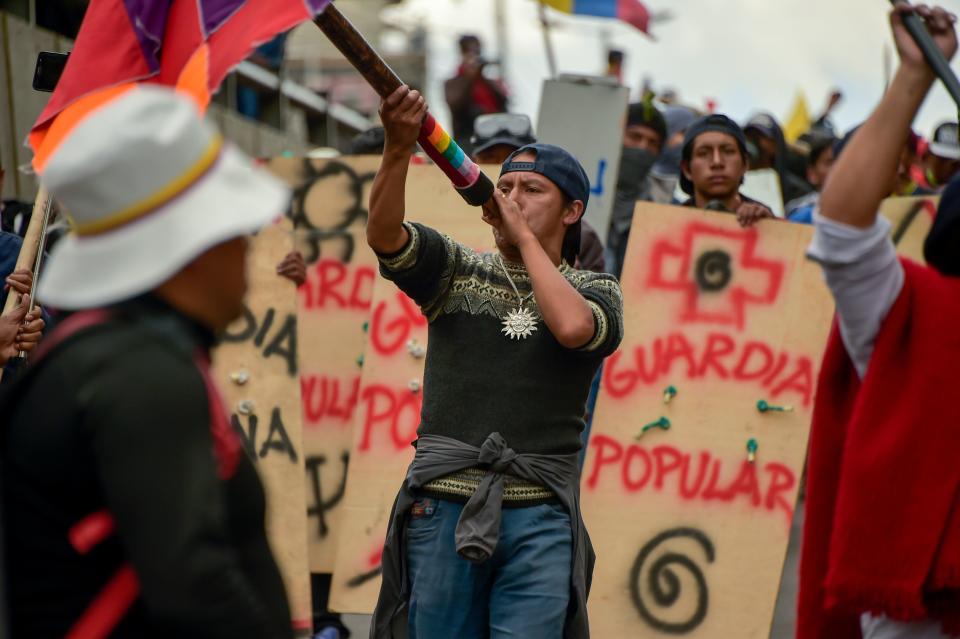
370;433;595;639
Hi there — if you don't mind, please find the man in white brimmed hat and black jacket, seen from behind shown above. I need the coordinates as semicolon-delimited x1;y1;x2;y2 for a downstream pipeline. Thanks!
0;85;292;639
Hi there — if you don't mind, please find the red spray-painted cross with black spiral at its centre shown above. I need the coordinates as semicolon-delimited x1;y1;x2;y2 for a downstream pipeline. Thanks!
646;222;784;329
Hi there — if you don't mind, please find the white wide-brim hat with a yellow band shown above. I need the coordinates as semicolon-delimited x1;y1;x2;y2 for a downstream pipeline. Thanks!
37;86;289;310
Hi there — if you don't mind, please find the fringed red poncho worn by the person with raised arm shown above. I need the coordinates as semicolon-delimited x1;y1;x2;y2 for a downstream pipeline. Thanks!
797;261;960;639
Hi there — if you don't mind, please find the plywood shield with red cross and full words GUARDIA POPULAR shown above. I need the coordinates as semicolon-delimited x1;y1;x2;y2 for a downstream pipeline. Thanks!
582;204;833;639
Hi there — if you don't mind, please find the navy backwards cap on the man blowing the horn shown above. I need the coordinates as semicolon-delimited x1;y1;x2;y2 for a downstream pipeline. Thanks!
500;142;590;264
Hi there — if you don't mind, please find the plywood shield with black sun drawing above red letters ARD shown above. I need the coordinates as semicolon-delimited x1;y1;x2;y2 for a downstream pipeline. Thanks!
270;157;380;573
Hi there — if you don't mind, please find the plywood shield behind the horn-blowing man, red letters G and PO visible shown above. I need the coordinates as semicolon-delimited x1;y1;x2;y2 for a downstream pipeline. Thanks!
330;166;493;613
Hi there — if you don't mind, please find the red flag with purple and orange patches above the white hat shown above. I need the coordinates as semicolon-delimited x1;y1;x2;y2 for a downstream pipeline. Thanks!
30;0;330;170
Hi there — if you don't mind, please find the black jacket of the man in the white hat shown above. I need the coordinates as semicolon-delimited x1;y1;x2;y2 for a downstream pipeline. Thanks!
0;297;292;639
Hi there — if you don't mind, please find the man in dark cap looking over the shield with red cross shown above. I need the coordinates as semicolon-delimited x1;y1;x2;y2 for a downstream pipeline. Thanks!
680;113;773;227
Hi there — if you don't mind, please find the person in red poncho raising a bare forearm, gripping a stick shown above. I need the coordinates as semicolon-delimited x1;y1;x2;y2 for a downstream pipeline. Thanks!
797;4;960;639
